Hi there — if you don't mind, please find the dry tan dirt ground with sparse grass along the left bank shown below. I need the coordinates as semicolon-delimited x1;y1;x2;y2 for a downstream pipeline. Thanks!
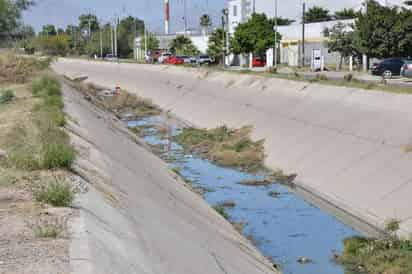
0;80;76;274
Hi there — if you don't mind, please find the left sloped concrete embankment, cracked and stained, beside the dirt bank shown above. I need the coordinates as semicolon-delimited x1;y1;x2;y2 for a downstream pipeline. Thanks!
64;83;276;274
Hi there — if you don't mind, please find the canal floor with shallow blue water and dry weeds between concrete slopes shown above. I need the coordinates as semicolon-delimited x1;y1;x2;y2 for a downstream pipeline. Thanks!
71;82;362;274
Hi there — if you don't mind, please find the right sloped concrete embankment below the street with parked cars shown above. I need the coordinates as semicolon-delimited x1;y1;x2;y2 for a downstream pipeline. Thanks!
54;59;412;234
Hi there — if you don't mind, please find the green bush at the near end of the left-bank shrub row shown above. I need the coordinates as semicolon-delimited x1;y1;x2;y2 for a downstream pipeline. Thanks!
42;143;76;169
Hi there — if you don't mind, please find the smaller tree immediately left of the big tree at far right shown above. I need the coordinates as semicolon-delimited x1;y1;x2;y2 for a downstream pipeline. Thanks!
326;23;359;66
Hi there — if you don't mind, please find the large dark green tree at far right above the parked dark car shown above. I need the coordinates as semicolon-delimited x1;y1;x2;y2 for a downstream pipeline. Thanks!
355;0;412;58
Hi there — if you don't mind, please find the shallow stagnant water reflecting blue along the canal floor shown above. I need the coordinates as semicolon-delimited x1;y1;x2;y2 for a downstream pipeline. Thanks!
128;116;360;274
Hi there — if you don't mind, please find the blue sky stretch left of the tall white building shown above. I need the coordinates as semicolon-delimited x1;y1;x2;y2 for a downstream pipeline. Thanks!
24;0;224;31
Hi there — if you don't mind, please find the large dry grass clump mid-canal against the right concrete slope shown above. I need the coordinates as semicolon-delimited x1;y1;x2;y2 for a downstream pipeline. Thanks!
174;126;265;171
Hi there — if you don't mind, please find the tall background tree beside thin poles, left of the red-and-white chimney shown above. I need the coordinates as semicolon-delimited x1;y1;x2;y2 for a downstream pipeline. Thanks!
117;16;144;57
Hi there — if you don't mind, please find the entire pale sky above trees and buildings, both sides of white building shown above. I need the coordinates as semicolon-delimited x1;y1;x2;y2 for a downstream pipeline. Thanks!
24;0;401;32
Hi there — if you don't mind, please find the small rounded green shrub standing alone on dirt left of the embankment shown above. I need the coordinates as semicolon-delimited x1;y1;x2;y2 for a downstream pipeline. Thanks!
34;179;74;207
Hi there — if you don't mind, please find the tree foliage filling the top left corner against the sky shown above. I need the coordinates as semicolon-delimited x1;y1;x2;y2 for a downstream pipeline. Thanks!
0;0;34;37
